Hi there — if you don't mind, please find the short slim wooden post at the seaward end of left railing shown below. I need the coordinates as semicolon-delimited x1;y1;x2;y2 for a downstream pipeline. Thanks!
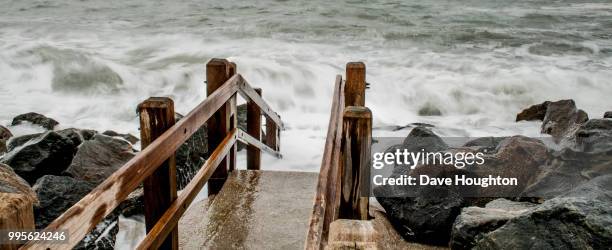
247;88;261;170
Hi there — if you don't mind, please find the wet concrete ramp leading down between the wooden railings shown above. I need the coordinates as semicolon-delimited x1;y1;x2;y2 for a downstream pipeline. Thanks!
179;170;318;249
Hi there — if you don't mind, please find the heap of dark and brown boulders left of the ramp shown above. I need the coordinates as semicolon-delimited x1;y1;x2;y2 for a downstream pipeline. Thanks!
0;107;252;249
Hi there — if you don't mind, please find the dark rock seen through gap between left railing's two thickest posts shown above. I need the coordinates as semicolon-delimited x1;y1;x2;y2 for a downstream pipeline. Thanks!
175;113;208;189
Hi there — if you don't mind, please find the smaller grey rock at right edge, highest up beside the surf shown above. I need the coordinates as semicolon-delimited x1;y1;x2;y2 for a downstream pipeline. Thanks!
574;119;612;152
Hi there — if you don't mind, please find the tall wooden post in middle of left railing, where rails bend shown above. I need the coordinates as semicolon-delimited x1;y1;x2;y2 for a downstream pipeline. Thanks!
206;58;235;195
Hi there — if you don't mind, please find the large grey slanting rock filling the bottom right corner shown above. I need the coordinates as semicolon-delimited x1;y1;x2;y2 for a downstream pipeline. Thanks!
474;175;612;249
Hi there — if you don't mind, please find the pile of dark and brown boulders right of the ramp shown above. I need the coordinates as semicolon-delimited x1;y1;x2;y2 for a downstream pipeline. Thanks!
374;100;612;249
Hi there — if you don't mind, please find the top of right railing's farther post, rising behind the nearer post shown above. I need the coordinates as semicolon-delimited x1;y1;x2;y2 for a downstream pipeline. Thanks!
344;62;366;107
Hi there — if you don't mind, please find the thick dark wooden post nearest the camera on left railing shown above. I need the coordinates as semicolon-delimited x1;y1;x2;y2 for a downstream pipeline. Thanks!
138;97;178;249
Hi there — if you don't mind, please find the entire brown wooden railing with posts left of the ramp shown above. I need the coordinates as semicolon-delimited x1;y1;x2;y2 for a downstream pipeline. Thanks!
22;59;283;249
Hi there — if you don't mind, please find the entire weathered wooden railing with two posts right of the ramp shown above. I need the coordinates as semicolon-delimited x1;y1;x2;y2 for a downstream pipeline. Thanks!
305;62;372;249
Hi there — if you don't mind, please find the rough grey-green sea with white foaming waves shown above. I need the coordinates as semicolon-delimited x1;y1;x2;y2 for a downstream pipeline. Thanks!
0;0;612;170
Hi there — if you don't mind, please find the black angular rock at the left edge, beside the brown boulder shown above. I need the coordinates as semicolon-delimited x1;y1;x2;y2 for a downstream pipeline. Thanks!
2;131;77;184
